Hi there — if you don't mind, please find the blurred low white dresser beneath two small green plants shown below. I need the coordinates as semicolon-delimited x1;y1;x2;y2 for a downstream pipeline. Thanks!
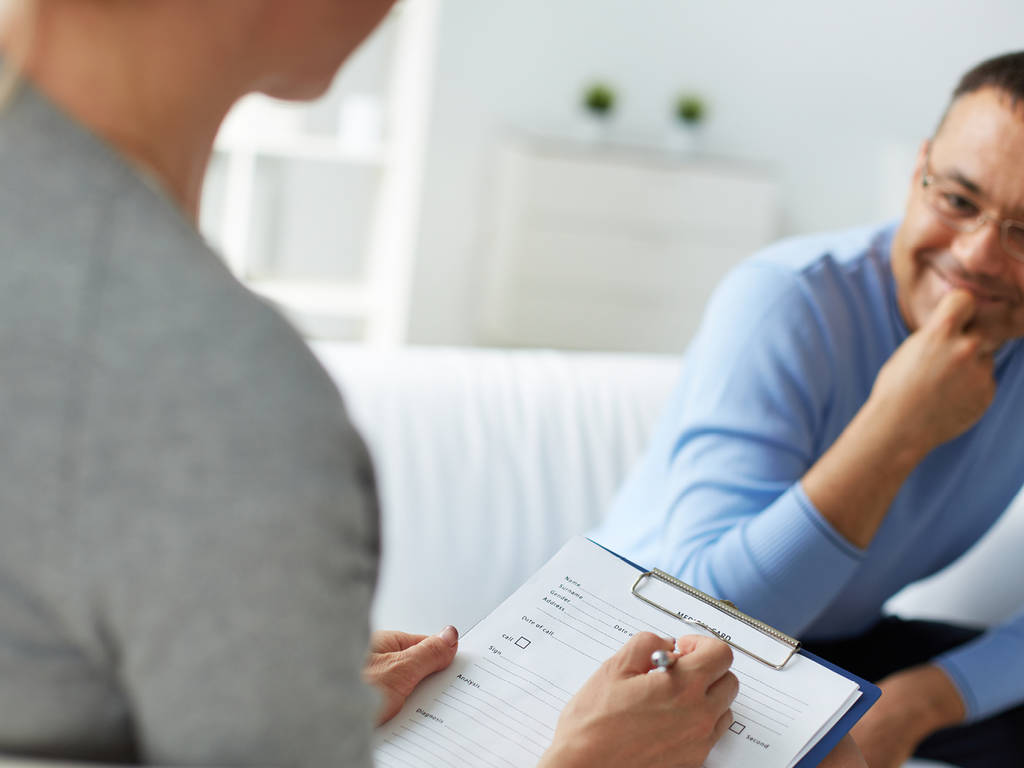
479;138;778;352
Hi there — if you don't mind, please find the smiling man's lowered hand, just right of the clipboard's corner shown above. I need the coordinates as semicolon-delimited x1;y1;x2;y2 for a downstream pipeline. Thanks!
852;665;965;768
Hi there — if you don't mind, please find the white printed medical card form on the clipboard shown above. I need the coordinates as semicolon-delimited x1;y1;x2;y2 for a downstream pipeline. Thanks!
375;538;859;768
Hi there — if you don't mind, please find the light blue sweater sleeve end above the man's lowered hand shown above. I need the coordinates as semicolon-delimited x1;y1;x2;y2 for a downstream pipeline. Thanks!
935;611;1024;722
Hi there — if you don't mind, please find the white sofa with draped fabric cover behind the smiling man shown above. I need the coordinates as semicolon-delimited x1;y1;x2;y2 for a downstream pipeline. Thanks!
314;344;1024;766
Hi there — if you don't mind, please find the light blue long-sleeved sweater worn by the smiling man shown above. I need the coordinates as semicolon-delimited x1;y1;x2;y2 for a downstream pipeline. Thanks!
593;225;1024;720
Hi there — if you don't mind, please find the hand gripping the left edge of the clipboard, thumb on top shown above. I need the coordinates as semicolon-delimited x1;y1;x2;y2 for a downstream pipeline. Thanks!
362;627;459;725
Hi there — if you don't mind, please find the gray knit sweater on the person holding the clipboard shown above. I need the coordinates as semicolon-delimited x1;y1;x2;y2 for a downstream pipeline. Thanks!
0;81;378;768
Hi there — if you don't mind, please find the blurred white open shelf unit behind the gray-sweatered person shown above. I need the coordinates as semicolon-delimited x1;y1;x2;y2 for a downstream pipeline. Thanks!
201;0;439;344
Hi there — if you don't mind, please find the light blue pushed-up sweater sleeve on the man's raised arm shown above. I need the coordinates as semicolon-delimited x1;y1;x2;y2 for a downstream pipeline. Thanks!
658;261;862;635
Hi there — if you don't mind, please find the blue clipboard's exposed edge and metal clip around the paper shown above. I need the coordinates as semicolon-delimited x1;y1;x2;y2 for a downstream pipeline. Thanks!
589;539;882;768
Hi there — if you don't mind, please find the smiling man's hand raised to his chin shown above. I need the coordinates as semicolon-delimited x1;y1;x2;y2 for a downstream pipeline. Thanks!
869;290;996;456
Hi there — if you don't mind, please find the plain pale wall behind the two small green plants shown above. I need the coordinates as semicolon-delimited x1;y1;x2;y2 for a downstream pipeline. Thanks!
411;0;1024;344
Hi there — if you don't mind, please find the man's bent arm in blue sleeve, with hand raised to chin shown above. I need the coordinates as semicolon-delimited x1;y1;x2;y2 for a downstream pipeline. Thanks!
622;274;994;634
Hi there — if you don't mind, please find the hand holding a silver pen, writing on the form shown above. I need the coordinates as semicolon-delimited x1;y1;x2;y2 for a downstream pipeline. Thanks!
539;632;739;768
